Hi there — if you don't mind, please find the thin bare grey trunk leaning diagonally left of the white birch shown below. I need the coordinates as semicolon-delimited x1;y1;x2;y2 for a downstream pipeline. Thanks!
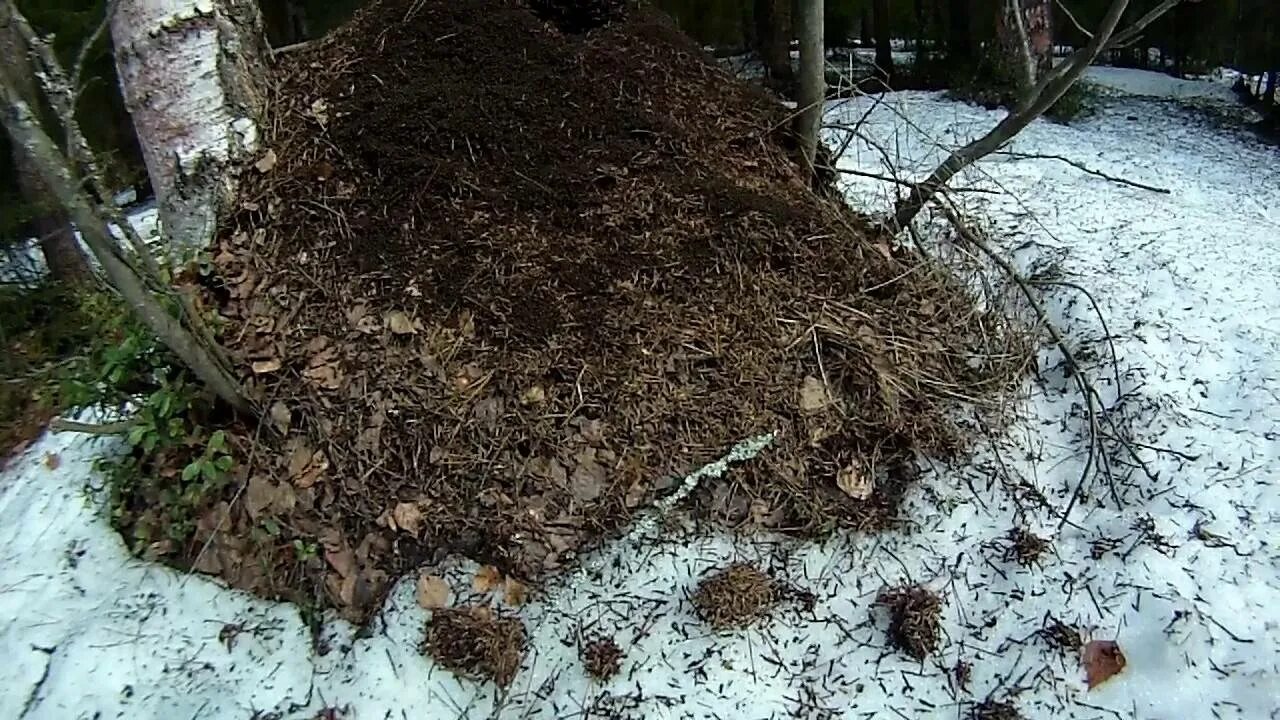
0;72;253;413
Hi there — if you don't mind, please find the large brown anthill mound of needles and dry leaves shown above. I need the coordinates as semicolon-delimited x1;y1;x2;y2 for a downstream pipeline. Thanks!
192;0;1024;618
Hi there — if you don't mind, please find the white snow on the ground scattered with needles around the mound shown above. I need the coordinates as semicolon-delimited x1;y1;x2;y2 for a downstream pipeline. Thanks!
0;65;1280;719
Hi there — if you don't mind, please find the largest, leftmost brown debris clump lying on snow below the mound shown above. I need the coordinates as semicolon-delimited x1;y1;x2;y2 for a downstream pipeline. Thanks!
422;607;527;687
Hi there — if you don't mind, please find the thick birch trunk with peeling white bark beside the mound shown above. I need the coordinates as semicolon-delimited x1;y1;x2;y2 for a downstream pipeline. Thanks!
111;0;269;254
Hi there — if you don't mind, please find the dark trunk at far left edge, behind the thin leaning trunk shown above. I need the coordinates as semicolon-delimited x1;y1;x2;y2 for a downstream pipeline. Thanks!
0;5;92;283
